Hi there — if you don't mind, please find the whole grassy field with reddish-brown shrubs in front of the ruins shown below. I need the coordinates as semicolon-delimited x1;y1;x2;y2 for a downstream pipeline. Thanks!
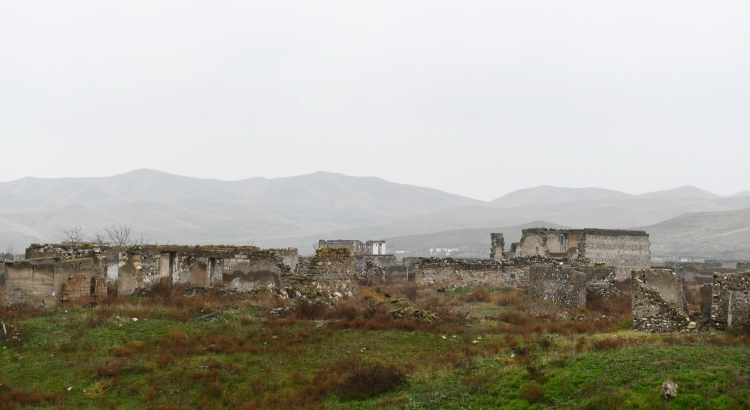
0;285;750;409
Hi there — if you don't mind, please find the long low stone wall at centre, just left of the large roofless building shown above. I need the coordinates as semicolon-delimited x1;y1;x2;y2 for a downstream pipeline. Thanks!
413;258;528;287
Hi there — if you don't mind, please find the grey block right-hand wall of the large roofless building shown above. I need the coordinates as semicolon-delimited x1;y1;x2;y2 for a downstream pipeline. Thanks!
578;229;651;280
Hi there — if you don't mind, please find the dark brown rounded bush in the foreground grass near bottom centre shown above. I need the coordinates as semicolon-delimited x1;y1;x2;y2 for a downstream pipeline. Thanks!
339;362;406;399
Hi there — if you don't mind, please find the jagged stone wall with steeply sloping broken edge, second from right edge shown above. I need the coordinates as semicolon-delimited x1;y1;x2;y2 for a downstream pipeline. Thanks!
631;269;695;333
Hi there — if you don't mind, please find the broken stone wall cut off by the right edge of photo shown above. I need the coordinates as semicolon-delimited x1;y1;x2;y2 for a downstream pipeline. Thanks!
710;271;750;330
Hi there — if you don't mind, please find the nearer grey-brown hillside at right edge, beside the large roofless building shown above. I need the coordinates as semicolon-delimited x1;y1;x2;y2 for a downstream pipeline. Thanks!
642;208;750;260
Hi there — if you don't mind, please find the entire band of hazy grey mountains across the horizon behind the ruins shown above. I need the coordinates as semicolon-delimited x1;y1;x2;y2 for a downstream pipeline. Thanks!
0;170;750;257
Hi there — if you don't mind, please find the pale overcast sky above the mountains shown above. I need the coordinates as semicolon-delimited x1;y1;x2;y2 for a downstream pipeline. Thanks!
0;0;750;200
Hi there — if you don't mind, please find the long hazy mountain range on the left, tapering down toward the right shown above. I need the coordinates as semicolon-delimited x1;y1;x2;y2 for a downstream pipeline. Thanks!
0;170;483;244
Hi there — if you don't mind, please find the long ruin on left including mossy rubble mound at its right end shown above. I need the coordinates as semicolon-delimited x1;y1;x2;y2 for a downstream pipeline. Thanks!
4;244;356;307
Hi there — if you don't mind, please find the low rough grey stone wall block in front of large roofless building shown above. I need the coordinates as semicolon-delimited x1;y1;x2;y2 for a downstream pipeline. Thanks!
528;263;616;308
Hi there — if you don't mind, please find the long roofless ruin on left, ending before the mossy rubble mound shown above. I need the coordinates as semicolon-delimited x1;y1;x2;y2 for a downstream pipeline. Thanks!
5;244;306;306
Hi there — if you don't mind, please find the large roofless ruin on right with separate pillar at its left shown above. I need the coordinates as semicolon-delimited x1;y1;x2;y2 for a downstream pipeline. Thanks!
491;228;651;280
